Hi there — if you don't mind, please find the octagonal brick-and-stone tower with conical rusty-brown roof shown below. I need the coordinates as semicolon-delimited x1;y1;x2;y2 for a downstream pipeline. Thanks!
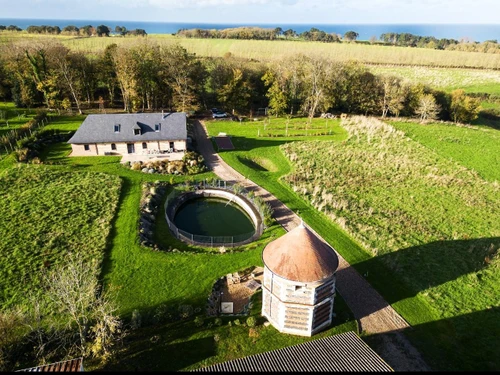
262;222;339;336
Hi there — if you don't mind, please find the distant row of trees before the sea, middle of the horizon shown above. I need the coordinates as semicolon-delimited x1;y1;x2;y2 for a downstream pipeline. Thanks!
176;27;344;43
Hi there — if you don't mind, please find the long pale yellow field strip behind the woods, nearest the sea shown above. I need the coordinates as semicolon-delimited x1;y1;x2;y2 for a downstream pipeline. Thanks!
0;33;500;69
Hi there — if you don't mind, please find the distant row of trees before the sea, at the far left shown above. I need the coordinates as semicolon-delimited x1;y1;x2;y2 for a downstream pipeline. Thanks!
0;25;147;36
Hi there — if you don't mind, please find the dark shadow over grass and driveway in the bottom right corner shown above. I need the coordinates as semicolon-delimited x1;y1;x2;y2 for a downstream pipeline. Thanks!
363;306;500;371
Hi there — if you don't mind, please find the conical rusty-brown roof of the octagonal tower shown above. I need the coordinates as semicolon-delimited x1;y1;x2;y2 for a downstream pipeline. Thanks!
262;223;339;282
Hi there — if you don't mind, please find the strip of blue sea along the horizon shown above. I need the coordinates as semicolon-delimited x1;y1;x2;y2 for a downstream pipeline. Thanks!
0;18;500;42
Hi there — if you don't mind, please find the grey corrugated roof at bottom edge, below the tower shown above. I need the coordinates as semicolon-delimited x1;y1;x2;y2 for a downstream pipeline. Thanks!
193;331;394;372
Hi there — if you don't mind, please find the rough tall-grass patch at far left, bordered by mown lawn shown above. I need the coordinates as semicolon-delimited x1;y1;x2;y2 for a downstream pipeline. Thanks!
0;166;120;307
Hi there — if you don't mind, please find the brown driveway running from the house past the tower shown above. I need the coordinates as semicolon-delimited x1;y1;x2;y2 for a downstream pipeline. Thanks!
194;121;430;371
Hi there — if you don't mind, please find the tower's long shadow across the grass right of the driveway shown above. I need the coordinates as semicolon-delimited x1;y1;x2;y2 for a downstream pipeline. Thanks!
337;237;500;319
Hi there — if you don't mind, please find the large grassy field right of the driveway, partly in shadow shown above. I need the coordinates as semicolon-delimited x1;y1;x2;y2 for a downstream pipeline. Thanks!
203;116;500;370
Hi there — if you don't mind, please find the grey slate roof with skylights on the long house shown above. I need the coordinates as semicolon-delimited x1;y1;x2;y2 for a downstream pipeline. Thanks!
68;112;187;144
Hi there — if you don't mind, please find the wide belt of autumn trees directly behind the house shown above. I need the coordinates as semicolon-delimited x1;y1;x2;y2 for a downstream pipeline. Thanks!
0;42;480;122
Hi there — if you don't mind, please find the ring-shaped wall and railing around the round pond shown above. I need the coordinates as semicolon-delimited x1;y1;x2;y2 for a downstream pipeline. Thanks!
164;180;264;247
